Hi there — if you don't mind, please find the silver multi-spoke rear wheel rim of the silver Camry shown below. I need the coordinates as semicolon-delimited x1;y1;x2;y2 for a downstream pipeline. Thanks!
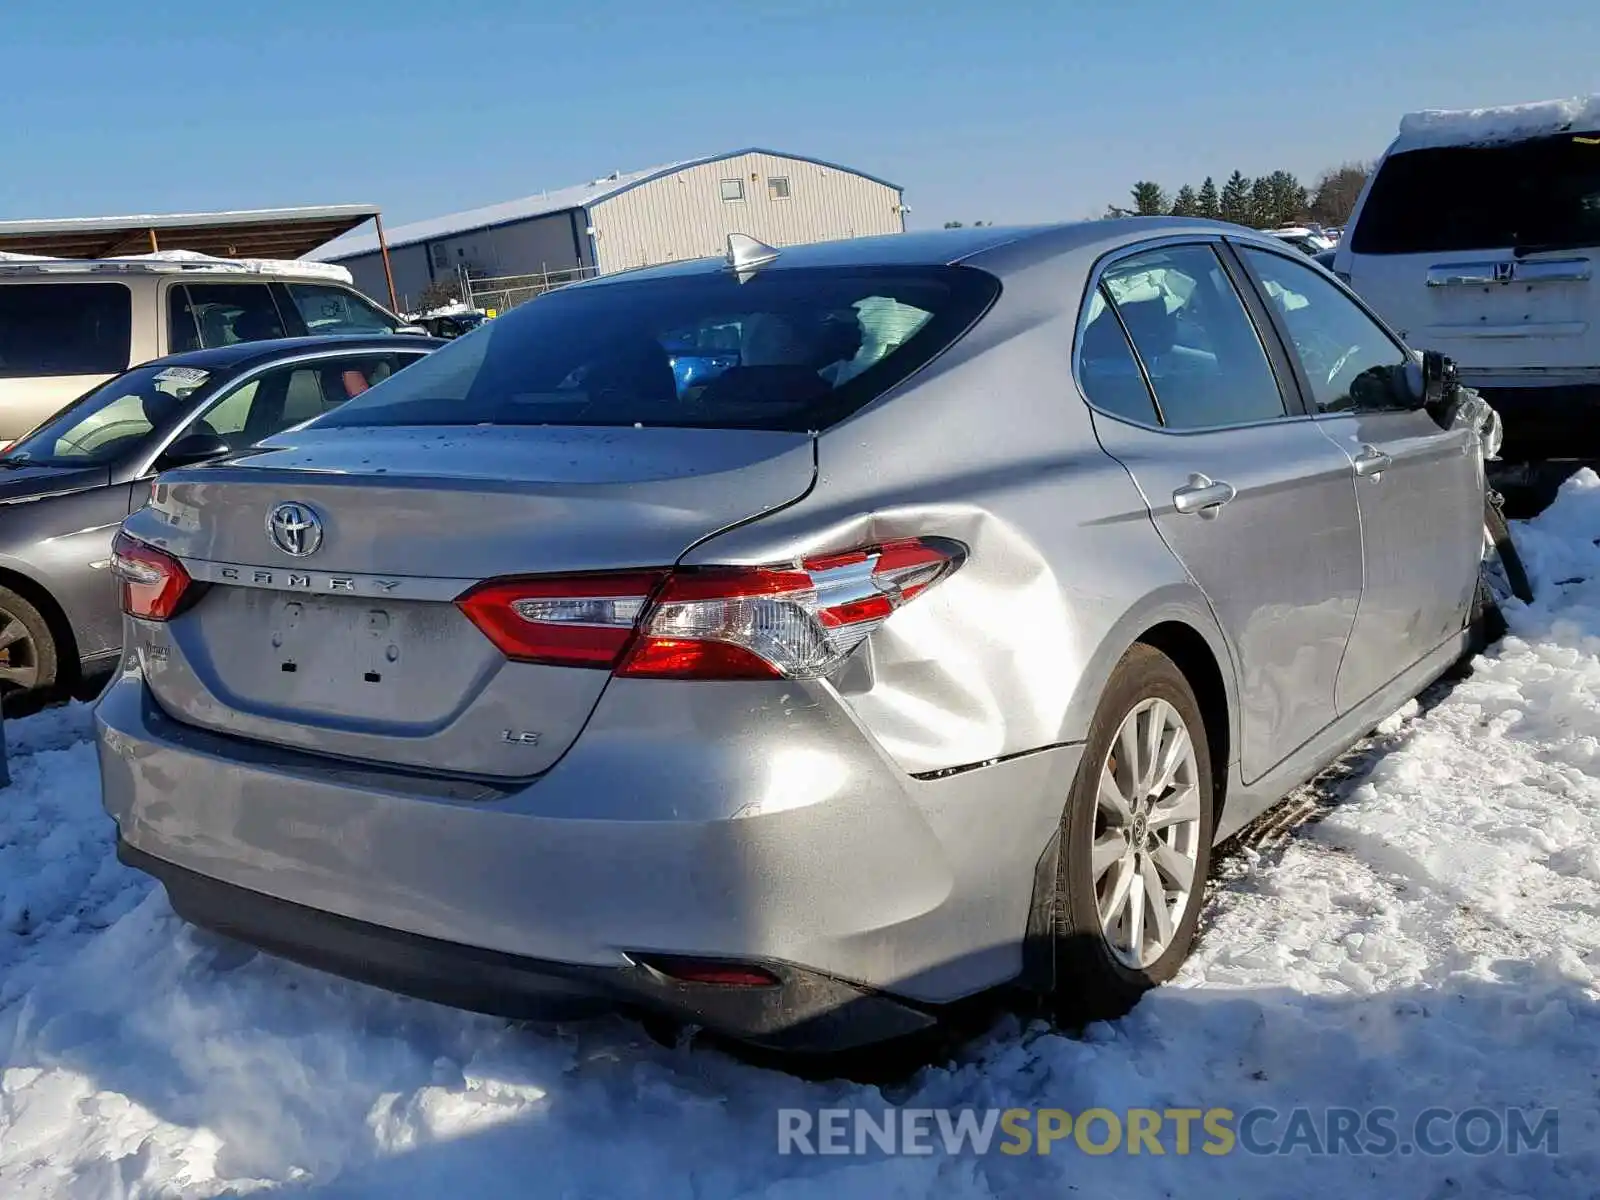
1090;699;1200;968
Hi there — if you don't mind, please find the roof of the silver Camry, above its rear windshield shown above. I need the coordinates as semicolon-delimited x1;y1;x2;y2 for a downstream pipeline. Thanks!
570;216;1266;288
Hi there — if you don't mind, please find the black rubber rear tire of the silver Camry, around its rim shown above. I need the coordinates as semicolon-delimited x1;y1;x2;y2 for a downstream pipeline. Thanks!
1054;645;1216;1024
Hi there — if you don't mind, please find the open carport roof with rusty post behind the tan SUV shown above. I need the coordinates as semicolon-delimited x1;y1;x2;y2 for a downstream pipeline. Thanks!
0;205;398;309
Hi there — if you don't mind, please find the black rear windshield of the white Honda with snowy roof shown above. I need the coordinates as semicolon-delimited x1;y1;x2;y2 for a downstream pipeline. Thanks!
1350;133;1600;254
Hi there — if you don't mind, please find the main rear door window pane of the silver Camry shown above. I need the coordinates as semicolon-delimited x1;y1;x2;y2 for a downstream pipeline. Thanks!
1101;246;1285;429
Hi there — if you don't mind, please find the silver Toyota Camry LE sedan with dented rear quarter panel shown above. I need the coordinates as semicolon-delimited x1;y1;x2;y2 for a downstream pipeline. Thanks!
96;219;1483;1050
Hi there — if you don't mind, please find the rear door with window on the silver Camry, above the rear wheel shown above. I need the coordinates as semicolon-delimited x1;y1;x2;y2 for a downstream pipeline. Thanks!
1078;240;1362;782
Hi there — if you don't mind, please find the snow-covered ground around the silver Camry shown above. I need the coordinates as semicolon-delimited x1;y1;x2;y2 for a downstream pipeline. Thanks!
0;474;1600;1200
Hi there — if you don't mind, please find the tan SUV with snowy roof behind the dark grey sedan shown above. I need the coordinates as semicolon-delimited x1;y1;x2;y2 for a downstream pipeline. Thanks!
0;251;408;442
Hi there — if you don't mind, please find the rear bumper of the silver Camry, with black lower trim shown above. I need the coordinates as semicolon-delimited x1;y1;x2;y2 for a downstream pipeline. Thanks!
96;670;1080;1046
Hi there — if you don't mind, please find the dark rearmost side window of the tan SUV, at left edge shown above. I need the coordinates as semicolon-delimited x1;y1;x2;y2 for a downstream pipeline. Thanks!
0;283;133;379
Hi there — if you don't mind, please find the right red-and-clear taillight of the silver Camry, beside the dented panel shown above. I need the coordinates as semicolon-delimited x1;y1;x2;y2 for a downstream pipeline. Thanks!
458;538;966;680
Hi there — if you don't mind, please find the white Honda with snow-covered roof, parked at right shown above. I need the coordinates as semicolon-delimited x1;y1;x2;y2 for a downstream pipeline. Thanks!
1333;96;1600;462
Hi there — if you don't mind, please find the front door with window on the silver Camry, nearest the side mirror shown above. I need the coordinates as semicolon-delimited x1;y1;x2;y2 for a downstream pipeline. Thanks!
1240;246;1483;712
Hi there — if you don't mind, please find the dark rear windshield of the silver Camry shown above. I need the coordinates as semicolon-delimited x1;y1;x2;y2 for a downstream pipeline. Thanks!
308;267;1000;432
